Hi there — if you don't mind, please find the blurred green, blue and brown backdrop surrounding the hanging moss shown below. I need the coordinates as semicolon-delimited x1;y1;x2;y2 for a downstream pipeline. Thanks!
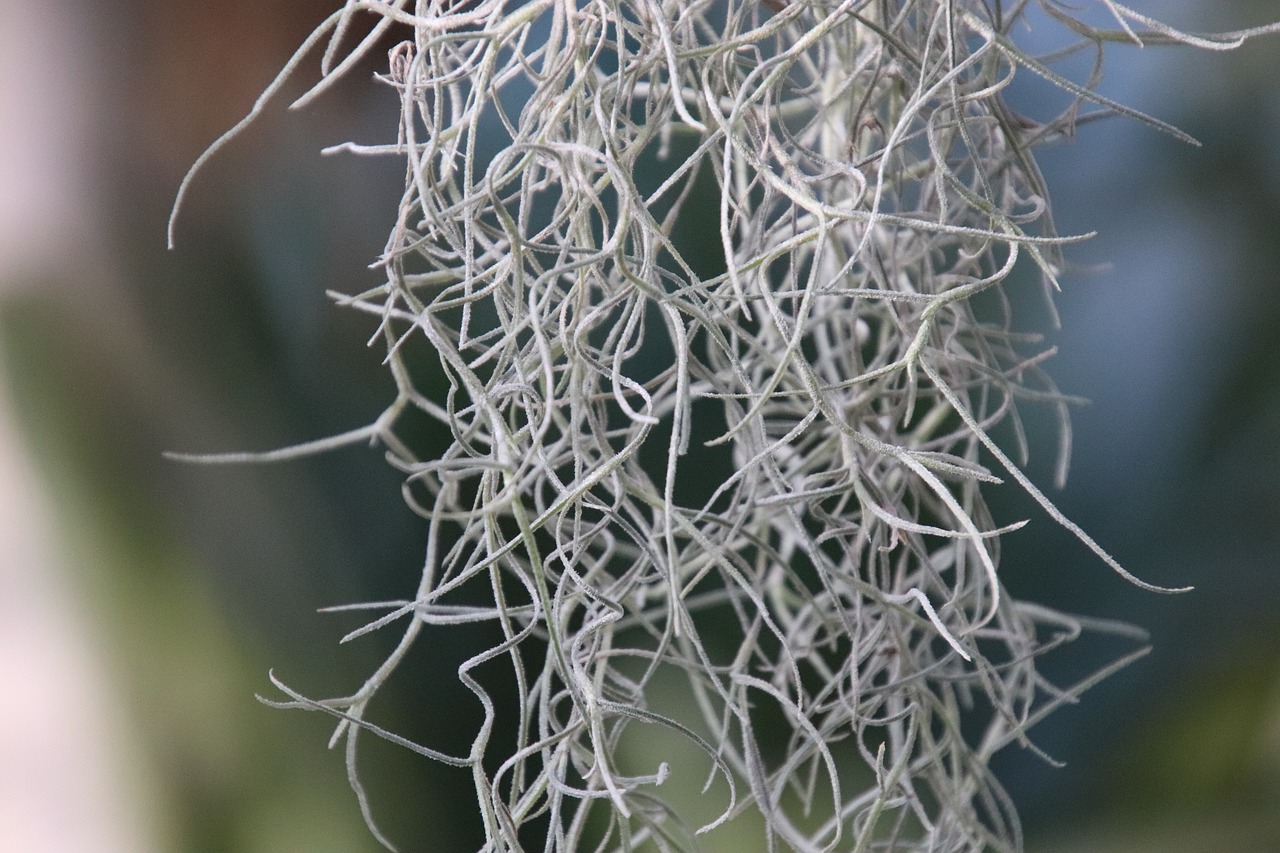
0;0;1280;853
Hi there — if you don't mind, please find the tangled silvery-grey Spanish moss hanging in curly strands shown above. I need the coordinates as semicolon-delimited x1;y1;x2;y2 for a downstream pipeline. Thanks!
167;0;1263;853
